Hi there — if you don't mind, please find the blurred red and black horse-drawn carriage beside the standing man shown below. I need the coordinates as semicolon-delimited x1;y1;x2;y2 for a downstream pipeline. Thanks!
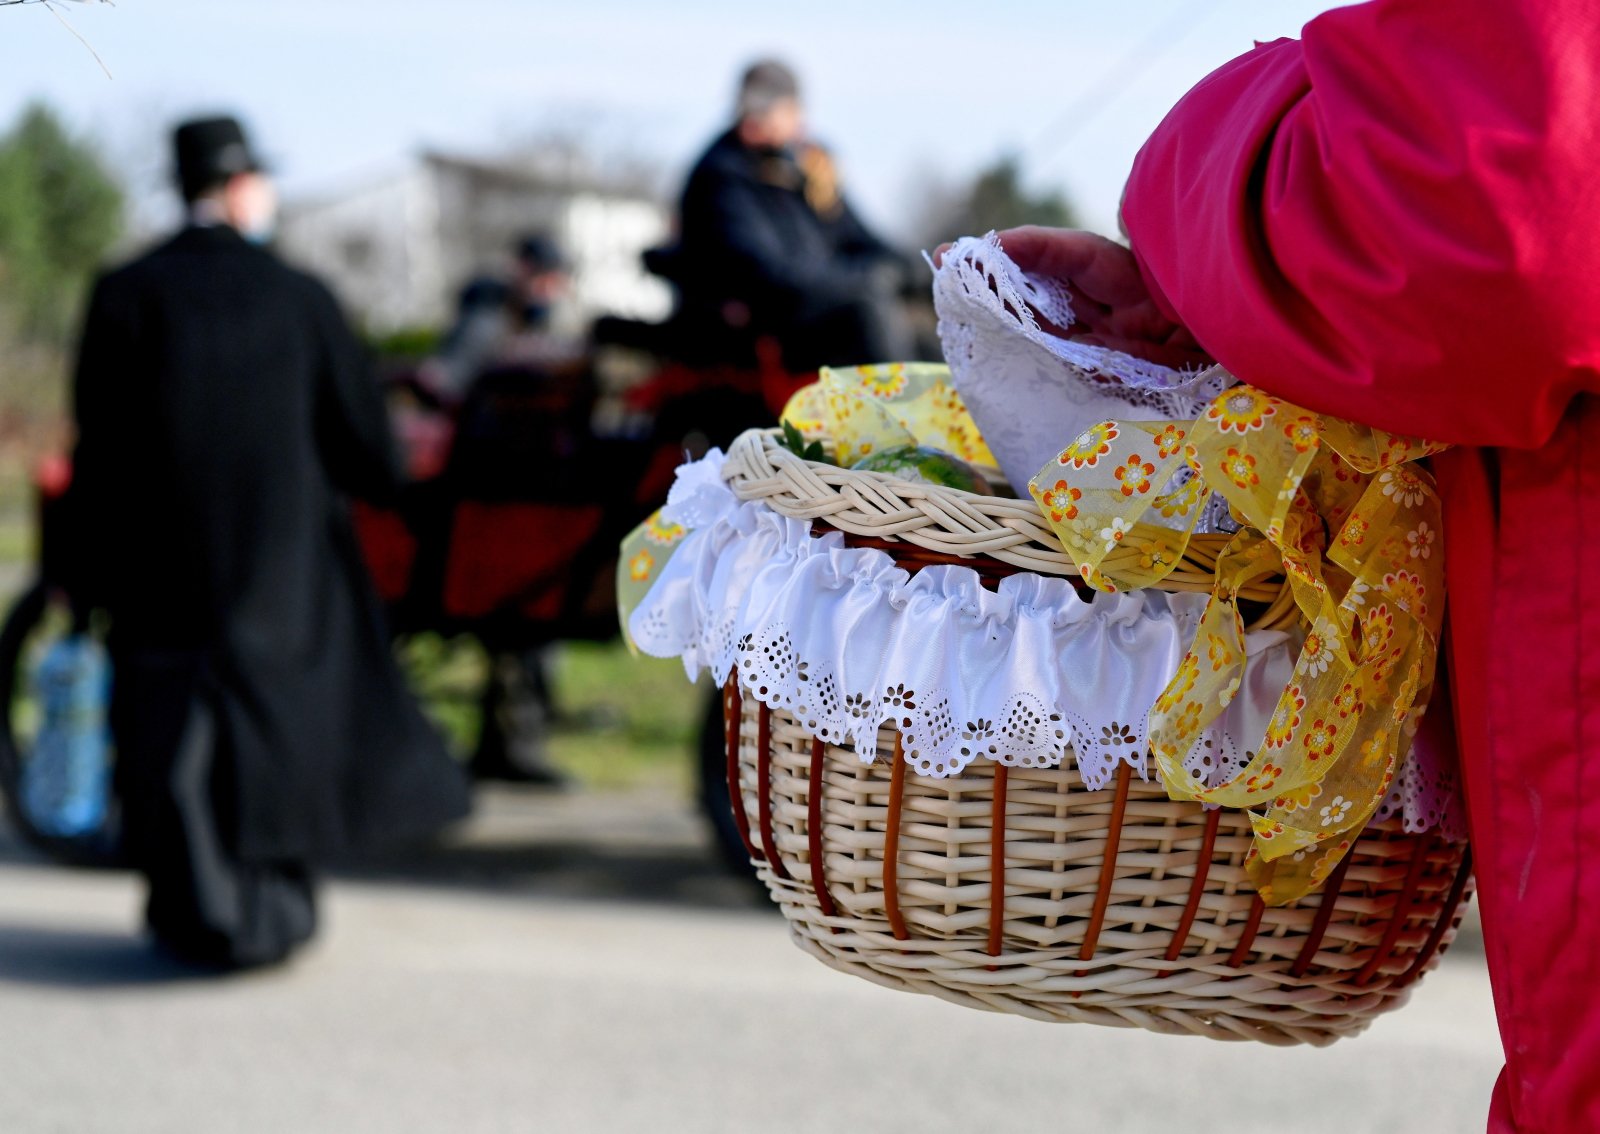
0;323;803;864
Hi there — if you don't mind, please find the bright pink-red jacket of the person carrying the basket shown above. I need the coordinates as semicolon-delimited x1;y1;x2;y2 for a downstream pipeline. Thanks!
1123;0;1600;1134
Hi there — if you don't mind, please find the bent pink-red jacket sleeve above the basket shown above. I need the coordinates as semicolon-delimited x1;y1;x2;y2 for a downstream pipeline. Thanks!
1123;0;1600;446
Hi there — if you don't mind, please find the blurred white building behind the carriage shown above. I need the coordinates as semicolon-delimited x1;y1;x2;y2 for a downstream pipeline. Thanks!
277;152;672;334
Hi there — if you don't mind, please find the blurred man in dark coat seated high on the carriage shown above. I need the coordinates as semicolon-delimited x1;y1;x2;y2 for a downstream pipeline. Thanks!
672;61;915;371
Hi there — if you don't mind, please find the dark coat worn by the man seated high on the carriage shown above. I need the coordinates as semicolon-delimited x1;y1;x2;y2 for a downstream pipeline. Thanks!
678;130;899;328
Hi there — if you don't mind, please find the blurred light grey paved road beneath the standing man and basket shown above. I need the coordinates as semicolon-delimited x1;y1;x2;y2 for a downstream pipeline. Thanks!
0;793;1499;1134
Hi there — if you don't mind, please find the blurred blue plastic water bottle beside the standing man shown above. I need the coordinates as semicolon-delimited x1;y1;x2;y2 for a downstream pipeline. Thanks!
21;635;110;838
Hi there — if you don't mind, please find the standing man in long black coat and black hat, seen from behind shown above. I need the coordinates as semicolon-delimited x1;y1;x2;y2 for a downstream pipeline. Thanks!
64;118;467;966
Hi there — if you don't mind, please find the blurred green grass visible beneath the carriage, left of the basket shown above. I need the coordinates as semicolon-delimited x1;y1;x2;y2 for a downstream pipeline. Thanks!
402;633;709;793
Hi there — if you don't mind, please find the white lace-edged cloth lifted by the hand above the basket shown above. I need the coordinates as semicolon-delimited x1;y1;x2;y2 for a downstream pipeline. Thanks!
933;232;1234;531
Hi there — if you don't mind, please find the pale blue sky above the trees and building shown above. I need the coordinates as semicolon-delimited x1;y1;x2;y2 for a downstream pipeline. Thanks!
0;0;1334;241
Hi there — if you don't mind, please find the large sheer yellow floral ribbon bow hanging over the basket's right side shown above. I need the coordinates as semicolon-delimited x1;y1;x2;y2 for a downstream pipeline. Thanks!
1029;385;1445;904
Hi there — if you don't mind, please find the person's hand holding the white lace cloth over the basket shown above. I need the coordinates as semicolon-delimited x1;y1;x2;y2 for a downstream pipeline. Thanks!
933;226;1211;366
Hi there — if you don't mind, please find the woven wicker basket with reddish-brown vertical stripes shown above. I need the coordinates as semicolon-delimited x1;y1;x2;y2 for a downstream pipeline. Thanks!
725;433;1472;1044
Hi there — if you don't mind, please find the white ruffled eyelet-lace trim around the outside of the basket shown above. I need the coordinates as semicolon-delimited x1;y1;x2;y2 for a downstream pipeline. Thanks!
629;449;1453;830
